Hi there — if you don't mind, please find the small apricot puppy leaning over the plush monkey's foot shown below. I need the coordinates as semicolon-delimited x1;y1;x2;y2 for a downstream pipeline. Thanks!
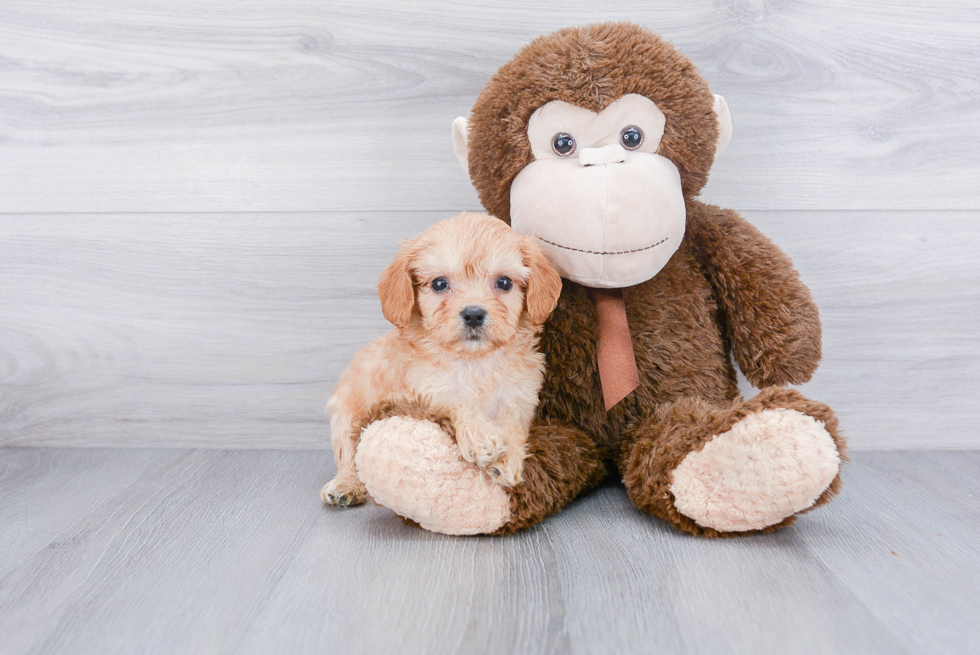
321;213;561;506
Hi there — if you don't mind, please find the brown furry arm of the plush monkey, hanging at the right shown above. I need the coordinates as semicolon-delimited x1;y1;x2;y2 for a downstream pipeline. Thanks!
688;202;820;387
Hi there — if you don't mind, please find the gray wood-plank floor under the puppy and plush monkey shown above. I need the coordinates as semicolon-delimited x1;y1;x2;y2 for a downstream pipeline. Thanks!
0;448;980;655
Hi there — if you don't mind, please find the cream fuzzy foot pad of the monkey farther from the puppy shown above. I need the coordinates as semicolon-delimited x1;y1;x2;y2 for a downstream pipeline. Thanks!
670;408;841;532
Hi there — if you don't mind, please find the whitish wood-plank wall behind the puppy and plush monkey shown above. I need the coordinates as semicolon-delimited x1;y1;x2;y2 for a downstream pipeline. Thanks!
0;0;980;449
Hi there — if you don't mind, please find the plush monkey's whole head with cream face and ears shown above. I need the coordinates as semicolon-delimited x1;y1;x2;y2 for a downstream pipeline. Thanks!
453;23;731;288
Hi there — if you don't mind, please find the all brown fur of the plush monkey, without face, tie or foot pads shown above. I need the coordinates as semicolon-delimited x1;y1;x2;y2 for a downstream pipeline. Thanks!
469;23;845;536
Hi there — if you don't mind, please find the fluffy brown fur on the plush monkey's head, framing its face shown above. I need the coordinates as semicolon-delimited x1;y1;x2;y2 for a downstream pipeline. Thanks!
469;23;718;223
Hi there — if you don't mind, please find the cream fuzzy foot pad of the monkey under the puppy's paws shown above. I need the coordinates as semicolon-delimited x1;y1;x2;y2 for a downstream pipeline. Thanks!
355;416;510;535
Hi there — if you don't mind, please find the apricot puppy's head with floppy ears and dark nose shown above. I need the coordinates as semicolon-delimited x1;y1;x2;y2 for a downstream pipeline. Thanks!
378;213;561;355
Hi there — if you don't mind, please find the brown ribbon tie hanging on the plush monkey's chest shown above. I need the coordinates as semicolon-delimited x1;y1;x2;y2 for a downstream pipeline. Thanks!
588;288;640;412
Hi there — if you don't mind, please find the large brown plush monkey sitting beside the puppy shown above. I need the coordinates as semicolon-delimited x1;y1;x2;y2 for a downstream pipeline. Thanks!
346;23;845;537
